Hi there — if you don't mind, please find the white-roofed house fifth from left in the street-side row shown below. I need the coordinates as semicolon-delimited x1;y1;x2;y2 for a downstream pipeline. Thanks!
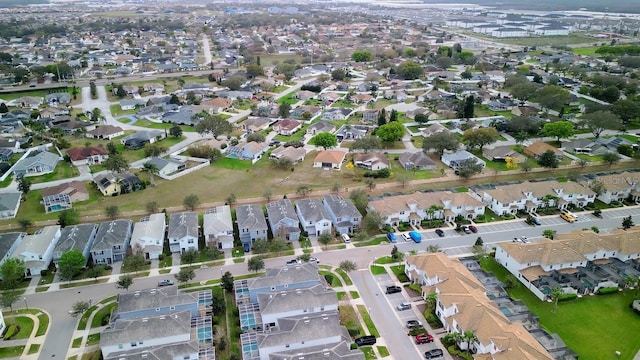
131;213;166;260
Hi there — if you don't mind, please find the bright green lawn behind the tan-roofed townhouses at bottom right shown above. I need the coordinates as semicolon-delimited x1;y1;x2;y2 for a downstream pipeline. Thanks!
481;257;640;360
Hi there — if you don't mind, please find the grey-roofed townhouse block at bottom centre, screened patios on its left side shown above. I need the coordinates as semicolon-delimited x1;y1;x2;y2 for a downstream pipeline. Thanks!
235;263;364;360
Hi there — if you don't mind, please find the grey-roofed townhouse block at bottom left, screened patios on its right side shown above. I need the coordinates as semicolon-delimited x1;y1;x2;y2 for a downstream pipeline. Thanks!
100;286;215;360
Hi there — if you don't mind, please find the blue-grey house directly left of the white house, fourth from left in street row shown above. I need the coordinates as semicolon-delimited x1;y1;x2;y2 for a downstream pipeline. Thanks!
91;220;133;265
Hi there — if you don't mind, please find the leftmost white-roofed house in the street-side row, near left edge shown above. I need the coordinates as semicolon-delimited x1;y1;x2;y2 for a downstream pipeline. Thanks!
12;225;60;276
